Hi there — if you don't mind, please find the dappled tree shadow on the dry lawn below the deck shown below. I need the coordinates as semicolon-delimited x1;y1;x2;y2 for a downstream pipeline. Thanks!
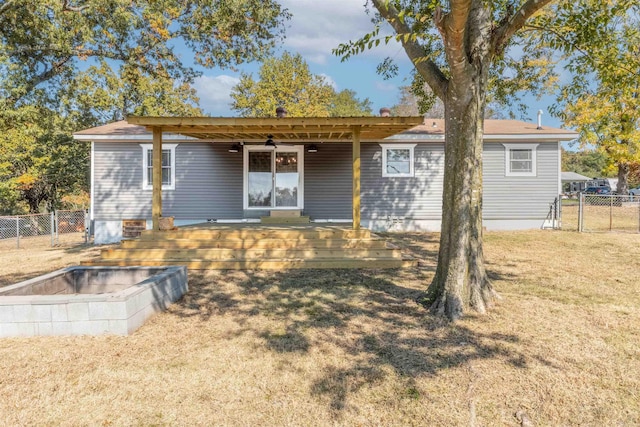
170;254;527;411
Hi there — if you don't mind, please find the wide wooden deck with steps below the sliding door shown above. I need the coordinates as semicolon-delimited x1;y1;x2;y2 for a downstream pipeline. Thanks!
82;224;417;270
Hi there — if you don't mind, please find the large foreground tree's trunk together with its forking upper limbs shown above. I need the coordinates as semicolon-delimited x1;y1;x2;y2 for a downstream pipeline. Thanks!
371;0;553;320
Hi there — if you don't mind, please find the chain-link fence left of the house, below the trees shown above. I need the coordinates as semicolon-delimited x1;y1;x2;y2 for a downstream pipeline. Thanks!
0;211;88;249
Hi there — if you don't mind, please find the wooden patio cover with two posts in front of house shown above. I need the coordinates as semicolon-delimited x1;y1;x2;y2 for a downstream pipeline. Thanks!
127;116;424;230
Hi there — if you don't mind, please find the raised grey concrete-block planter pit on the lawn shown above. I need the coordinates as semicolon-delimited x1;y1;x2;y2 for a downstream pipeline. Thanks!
0;266;188;337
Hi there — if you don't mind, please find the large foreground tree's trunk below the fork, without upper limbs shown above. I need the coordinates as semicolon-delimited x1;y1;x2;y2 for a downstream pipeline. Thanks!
427;60;496;320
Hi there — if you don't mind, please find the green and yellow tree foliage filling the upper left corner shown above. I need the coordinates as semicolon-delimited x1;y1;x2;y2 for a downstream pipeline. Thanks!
0;0;289;213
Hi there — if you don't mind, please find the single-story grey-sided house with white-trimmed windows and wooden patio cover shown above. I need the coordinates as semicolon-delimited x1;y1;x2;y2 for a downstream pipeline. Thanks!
74;117;577;243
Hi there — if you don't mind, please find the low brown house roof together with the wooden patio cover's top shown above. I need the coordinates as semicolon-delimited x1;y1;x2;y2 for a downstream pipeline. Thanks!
74;117;578;142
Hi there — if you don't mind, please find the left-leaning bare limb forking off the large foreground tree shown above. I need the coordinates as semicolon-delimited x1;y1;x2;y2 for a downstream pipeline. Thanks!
372;0;448;99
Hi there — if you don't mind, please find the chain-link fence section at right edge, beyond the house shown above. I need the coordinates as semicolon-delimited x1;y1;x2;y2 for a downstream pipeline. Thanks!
578;193;640;233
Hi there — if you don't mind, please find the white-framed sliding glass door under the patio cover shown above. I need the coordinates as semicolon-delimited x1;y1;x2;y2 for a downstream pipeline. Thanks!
244;145;304;210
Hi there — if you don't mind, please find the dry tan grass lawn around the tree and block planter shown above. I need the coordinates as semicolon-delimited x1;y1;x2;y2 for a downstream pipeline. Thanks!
0;231;640;426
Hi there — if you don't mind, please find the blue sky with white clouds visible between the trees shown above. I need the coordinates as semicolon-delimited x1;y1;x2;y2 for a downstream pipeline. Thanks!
188;0;561;127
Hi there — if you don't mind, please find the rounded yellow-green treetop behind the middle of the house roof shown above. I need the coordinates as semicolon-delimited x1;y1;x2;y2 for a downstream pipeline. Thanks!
231;52;371;117
